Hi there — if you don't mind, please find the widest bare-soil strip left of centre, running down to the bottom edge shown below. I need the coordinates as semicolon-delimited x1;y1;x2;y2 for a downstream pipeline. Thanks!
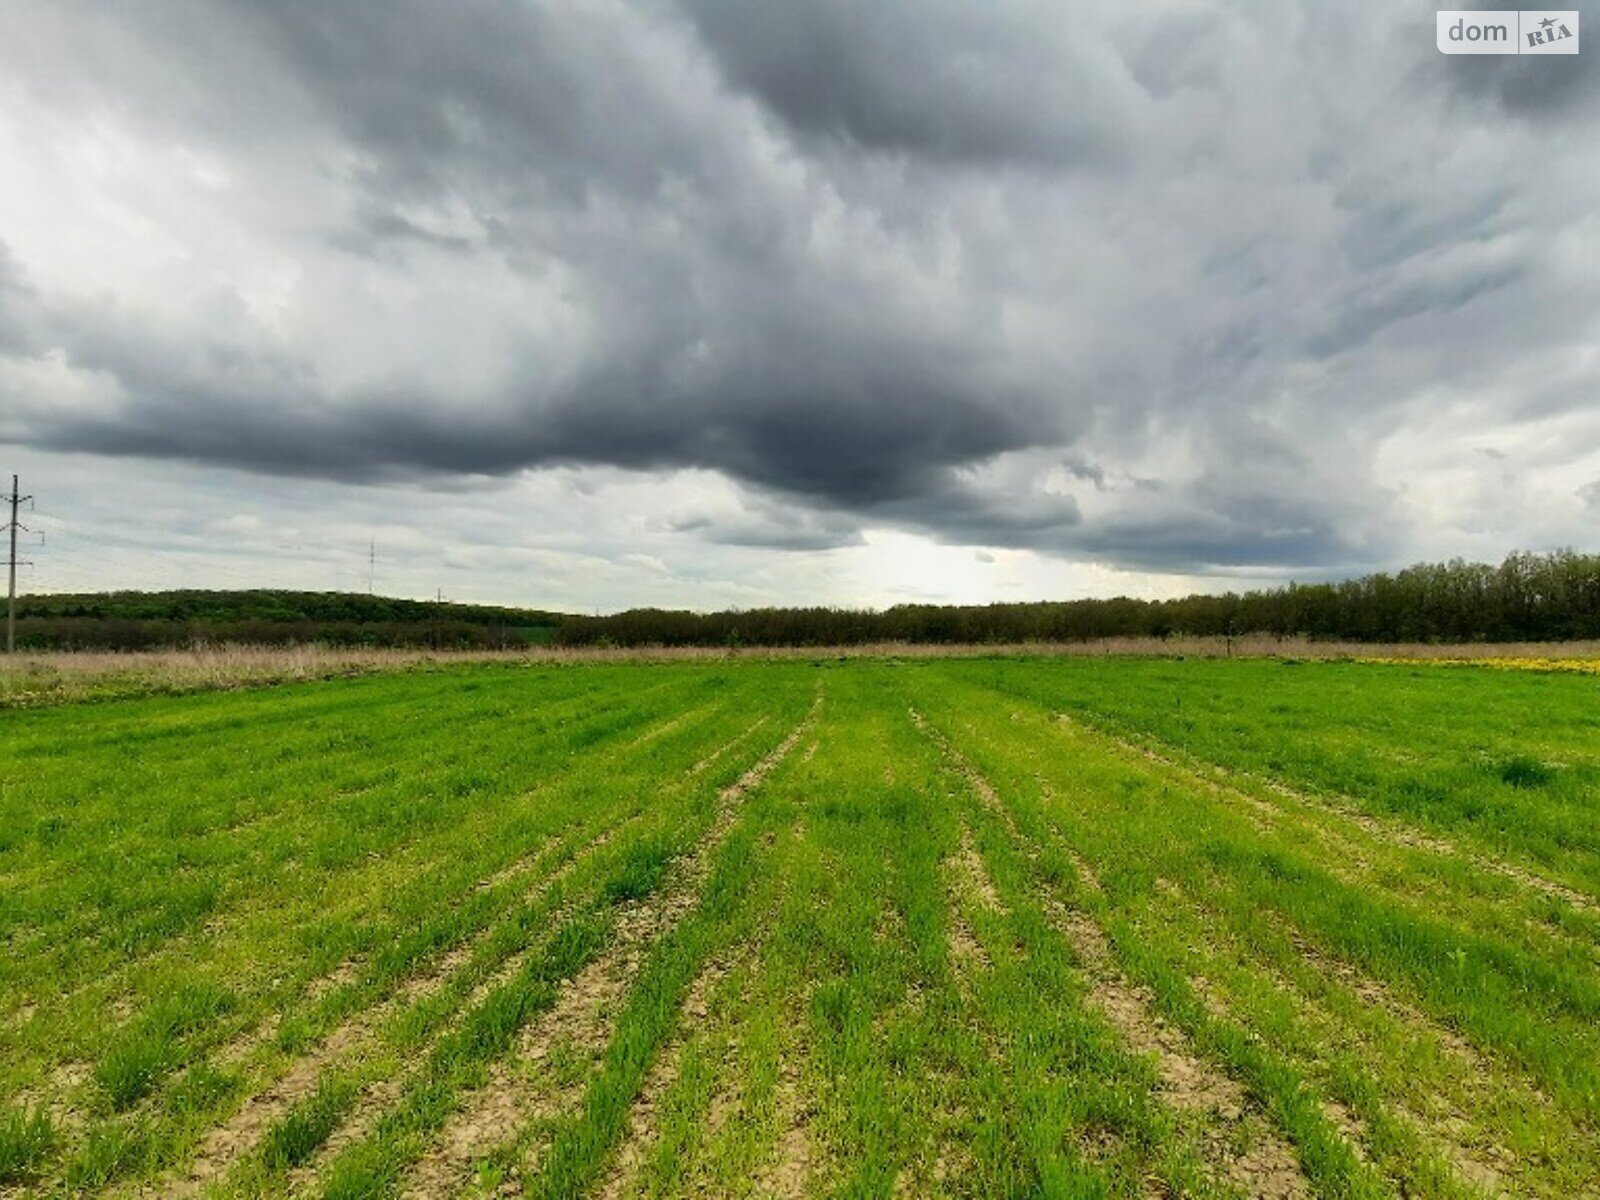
393;696;821;1200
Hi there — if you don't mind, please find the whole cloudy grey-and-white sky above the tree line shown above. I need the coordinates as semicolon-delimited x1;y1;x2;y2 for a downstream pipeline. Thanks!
0;0;1600;611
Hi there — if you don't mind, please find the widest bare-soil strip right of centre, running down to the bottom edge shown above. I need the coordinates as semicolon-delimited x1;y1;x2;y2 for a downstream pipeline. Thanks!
912;710;1310;1200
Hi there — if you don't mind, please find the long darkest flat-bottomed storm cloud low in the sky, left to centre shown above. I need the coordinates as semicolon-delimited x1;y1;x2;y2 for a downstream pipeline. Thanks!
18;267;1062;528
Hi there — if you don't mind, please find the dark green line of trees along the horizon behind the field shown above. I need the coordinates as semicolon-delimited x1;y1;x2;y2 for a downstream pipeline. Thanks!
18;550;1600;650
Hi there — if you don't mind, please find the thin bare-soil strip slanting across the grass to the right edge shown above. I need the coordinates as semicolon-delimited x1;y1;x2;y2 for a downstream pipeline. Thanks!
1056;712;1600;914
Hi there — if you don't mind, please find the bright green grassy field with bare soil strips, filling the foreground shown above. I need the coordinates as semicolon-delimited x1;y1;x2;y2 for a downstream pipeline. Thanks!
0;658;1600;1200
